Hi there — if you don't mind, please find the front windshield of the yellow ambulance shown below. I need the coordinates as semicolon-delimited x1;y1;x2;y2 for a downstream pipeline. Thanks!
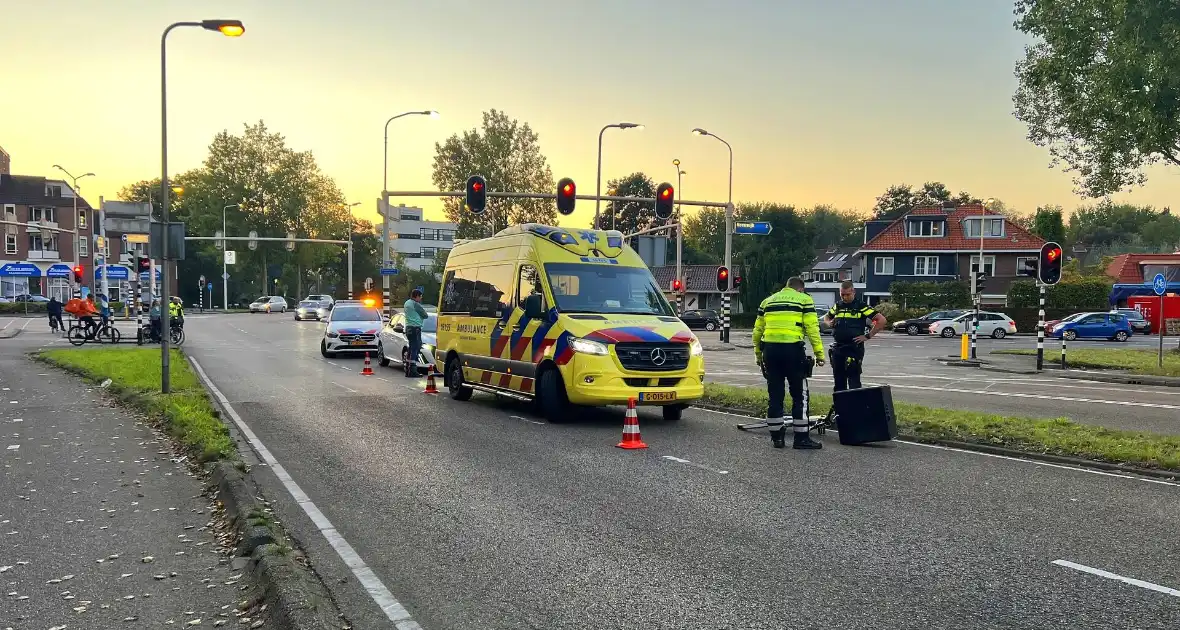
545;263;673;316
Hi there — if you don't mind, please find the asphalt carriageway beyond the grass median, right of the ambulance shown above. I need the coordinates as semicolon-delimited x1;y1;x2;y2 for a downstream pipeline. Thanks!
706;333;1180;434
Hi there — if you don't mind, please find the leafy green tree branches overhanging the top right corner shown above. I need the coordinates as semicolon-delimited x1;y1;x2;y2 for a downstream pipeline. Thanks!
1012;0;1180;197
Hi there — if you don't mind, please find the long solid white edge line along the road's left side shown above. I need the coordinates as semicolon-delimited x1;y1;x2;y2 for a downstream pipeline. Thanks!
189;356;421;630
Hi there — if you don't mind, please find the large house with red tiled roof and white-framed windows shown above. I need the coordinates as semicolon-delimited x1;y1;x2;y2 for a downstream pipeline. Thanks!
857;203;1044;306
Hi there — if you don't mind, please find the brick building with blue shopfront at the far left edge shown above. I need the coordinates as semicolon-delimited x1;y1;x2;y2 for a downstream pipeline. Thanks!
0;149;94;300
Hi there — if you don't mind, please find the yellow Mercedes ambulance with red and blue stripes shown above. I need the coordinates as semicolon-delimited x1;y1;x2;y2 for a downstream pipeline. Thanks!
435;223;704;422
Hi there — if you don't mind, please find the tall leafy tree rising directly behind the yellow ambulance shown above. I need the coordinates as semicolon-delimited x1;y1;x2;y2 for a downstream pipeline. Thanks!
433;110;557;238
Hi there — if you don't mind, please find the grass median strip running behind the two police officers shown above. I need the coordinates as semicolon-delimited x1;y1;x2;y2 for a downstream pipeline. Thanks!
702;383;1180;471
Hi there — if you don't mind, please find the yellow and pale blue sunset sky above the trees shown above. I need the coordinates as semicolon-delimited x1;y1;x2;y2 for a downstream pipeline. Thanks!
9;0;1180;232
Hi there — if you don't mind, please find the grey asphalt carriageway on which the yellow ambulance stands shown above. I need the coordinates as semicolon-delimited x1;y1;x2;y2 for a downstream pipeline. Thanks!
110;315;1180;630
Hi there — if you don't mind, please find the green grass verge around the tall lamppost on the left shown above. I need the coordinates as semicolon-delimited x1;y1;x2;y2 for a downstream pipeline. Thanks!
37;347;237;461
